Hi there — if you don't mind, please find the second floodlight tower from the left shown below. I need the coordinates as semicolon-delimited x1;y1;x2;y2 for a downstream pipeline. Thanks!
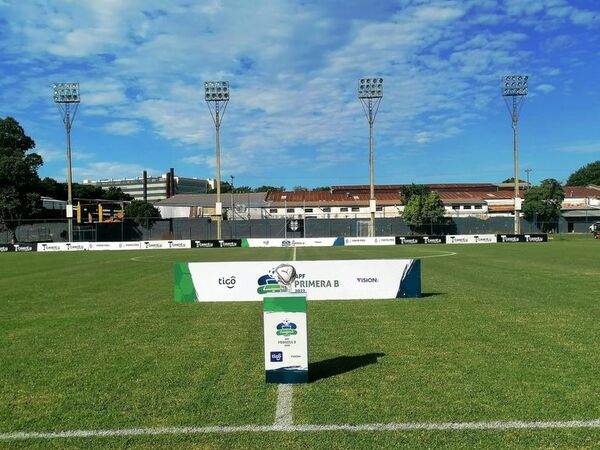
204;81;229;239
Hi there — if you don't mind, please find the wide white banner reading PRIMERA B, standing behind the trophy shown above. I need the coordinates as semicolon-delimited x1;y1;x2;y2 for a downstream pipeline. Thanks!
174;259;421;302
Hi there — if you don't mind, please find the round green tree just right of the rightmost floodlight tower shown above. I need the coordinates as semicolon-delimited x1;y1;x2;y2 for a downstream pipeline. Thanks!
523;178;565;231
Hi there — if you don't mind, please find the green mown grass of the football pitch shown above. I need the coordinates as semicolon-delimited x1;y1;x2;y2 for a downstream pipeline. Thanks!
0;239;600;448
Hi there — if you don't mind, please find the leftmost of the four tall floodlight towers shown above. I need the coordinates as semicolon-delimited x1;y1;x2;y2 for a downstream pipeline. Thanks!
52;83;80;242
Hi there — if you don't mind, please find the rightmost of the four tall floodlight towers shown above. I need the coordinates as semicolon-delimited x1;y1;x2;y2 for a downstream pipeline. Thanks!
502;75;529;234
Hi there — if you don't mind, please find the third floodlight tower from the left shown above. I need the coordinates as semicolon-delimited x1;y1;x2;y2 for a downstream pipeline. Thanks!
358;77;383;237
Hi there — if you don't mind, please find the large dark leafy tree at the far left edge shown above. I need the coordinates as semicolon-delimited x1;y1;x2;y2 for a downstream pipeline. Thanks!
0;117;43;243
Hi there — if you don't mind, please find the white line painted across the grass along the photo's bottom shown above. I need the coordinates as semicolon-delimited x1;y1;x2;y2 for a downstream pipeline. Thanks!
0;419;600;441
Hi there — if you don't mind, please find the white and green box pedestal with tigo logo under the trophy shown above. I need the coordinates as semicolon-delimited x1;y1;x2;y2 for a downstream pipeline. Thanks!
263;292;308;384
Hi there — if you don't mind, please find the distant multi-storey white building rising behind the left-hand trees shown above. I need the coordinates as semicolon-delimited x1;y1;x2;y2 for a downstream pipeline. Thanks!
83;169;209;203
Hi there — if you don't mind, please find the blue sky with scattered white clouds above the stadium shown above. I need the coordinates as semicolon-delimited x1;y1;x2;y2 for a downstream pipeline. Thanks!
0;0;600;188
